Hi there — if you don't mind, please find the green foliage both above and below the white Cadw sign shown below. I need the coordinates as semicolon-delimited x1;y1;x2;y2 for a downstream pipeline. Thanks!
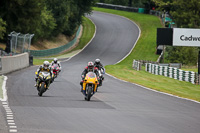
153;0;200;65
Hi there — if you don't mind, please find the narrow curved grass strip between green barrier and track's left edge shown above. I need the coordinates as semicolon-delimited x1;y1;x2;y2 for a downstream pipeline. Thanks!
33;17;95;65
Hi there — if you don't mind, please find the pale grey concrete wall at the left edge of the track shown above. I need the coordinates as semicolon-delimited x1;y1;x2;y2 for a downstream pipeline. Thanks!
0;53;29;74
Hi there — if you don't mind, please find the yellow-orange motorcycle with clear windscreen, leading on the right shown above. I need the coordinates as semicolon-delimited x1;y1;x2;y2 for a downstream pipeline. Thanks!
83;72;98;101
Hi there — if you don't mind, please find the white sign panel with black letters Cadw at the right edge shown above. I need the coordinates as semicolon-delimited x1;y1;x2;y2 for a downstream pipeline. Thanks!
172;28;200;47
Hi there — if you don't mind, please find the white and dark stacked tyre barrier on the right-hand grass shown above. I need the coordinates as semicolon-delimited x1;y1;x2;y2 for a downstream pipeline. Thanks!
145;63;198;84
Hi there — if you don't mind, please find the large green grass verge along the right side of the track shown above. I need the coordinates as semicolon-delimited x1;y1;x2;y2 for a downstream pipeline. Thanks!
94;8;200;101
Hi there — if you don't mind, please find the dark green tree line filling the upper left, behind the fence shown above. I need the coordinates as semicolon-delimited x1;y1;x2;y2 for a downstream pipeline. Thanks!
0;0;94;40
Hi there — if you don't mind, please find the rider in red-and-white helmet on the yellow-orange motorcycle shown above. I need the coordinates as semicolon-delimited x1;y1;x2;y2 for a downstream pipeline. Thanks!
80;61;99;94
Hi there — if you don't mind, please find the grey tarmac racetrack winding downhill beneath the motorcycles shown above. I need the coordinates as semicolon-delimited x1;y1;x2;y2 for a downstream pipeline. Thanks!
1;12;200;133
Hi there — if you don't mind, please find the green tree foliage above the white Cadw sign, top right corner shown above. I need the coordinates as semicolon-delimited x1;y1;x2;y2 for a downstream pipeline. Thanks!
153;0;200;28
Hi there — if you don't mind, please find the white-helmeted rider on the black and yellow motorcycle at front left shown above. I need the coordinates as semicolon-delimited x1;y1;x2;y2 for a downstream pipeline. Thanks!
35;61;53;88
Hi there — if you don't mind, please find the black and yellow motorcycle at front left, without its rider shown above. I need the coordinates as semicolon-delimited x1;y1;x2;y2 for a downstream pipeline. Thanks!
35;72;52;96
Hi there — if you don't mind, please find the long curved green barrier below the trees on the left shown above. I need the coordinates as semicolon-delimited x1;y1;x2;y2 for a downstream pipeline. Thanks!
30;26;81;57
